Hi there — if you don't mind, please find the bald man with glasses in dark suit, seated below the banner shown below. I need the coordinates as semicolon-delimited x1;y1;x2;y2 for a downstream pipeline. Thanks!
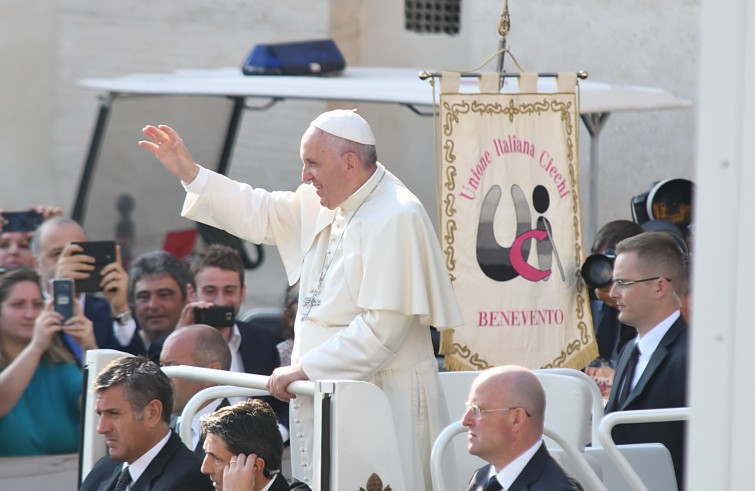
462;365;582;491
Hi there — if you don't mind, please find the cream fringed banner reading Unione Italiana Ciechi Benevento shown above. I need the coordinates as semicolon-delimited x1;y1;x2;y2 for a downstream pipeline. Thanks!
439;73;598;370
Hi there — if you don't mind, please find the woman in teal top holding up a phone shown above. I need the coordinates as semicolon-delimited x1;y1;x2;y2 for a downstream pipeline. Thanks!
0;268;96;457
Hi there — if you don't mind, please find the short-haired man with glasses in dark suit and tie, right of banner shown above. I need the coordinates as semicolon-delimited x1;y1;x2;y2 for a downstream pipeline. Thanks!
606;232;687;489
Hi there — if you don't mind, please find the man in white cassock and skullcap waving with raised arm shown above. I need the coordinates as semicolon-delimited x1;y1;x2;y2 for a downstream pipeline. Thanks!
139;110;462;491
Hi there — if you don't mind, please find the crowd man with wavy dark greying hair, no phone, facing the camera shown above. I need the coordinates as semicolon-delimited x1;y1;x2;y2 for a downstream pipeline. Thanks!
128;251;193;361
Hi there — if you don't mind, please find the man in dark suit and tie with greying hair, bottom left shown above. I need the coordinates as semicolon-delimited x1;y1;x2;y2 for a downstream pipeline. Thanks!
80;356;213;491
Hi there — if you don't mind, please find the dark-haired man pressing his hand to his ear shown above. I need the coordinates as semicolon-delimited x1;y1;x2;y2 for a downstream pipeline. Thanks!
200;399;307;491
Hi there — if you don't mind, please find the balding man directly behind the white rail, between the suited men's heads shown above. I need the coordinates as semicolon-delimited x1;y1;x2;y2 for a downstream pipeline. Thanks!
160;324;231;459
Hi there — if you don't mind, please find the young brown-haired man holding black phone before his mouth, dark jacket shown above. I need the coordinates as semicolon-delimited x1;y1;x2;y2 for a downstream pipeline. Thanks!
179;244;289;441
